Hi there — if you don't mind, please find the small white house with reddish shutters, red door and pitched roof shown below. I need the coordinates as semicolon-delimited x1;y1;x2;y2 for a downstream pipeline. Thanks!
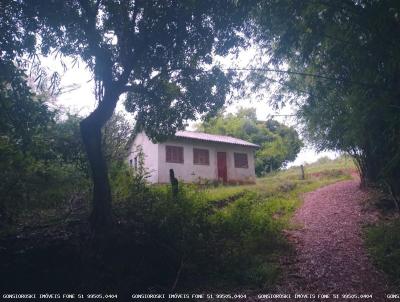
128;131;259;183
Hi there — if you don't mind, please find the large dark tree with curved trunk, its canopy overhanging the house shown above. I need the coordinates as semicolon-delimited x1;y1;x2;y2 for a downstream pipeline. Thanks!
23;0;250;231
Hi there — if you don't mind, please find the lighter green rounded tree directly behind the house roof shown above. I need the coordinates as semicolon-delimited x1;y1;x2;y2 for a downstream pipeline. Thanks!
197;108;303;176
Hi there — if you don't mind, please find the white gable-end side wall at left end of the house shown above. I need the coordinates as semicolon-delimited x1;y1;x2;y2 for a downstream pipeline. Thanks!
127;132;158;183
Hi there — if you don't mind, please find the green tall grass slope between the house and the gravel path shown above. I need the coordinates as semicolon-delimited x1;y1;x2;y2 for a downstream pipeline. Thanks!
122;156;351;288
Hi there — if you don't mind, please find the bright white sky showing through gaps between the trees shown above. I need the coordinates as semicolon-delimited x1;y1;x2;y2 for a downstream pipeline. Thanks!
42;49;338;166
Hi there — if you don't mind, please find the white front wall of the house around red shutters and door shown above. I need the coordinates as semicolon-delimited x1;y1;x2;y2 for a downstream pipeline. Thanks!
158;140;256;183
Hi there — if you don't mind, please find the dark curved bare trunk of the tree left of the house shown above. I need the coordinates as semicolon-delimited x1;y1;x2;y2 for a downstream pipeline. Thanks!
80;86;119;234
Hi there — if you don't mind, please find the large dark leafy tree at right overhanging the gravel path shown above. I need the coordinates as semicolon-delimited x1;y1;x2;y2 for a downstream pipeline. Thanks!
253;0;400;194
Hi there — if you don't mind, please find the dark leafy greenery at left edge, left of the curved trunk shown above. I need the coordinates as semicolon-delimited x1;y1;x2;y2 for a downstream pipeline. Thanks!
0;71;85;223
